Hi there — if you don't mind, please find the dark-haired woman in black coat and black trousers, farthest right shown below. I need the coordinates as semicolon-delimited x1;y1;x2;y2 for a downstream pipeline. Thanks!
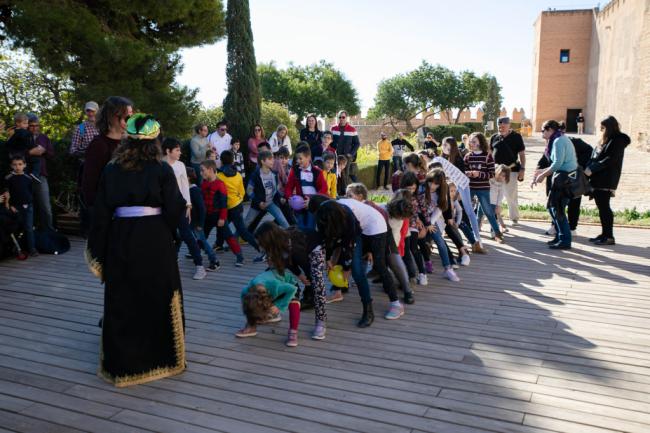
585;116;630;245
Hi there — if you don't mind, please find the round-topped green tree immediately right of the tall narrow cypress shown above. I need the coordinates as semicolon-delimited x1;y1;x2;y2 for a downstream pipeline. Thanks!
257;60;361;128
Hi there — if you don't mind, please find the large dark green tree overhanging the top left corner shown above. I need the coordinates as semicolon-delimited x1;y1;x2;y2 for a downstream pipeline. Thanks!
0;0;224;134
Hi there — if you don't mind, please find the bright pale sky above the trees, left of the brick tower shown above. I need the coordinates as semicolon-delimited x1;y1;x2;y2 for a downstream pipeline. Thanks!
178;0;605;114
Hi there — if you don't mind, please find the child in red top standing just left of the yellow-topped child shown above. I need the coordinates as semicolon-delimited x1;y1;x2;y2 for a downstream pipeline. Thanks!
201;159;244;267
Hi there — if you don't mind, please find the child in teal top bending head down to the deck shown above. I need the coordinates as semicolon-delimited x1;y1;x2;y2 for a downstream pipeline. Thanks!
235;269;300;347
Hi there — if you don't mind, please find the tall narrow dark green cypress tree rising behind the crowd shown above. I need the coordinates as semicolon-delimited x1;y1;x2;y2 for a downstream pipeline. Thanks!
223;0;261;154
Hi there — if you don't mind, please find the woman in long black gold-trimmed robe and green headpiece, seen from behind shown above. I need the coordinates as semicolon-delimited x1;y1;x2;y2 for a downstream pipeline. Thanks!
86;114;185;387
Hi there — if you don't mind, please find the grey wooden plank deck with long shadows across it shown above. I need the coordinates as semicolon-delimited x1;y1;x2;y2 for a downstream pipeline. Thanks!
0;223;650;433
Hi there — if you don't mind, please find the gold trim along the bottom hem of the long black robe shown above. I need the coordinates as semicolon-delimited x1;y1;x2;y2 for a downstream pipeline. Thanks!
97;290;185;388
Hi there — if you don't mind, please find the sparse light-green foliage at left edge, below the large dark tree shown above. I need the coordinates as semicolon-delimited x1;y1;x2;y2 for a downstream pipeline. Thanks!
0;50;82;139
